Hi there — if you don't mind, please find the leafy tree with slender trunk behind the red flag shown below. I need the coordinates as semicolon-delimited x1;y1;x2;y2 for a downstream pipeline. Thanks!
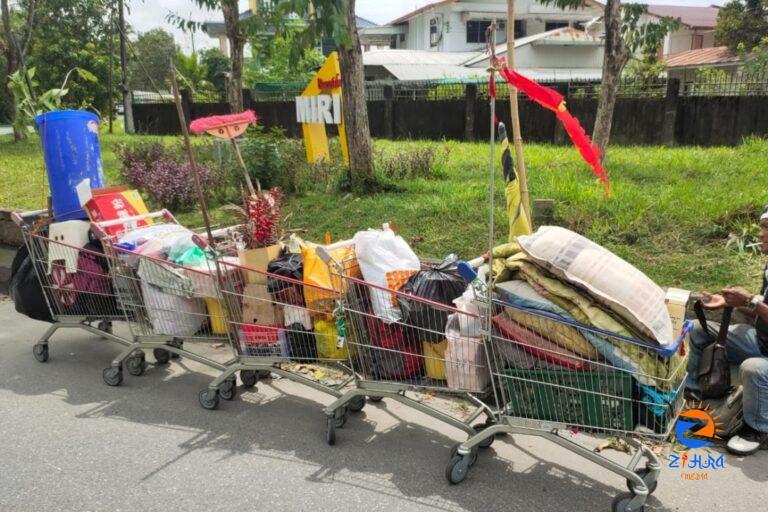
540;0;680;155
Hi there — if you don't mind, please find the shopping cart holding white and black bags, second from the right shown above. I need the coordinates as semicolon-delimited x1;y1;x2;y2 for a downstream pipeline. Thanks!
318;242;496;446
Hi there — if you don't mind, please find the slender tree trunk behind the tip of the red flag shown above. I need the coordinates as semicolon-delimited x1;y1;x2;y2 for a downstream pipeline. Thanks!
592;0;628;157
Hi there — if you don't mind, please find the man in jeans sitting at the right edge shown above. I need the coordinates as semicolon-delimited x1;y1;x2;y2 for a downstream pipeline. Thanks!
686;207;768;456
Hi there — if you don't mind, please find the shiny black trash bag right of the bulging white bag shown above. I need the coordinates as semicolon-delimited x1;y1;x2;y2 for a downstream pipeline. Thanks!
398;254;467;343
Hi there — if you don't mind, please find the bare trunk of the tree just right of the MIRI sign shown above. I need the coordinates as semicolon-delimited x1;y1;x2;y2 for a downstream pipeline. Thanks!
339;0;374;191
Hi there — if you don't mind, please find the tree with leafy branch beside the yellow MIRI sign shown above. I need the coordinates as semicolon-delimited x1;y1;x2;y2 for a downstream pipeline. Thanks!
278;0;375;191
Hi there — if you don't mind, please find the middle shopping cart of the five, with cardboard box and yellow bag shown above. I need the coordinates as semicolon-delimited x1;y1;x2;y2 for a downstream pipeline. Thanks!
199;251;358;411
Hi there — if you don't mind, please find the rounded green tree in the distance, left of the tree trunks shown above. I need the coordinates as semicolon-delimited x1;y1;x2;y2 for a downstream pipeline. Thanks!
128;28;179;91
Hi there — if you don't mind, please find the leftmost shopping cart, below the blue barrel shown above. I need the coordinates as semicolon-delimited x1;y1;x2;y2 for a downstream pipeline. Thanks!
12;210;130;363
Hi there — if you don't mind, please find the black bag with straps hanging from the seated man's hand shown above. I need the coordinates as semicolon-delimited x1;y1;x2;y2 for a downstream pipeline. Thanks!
693;301;733;399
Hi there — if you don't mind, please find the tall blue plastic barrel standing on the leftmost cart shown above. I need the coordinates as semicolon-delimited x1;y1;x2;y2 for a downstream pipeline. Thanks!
35;110;104;222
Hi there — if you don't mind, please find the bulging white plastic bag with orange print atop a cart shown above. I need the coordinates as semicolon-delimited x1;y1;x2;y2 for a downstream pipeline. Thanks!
353;224;421;323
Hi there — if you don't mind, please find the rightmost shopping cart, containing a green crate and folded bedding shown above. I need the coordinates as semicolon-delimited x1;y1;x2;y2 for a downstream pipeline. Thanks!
445;264;692;512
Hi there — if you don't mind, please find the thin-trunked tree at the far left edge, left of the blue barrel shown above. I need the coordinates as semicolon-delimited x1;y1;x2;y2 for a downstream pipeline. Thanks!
0;0;36;141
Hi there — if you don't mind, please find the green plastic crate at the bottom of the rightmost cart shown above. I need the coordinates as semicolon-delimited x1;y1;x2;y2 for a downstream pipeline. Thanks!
501;369;635;431
